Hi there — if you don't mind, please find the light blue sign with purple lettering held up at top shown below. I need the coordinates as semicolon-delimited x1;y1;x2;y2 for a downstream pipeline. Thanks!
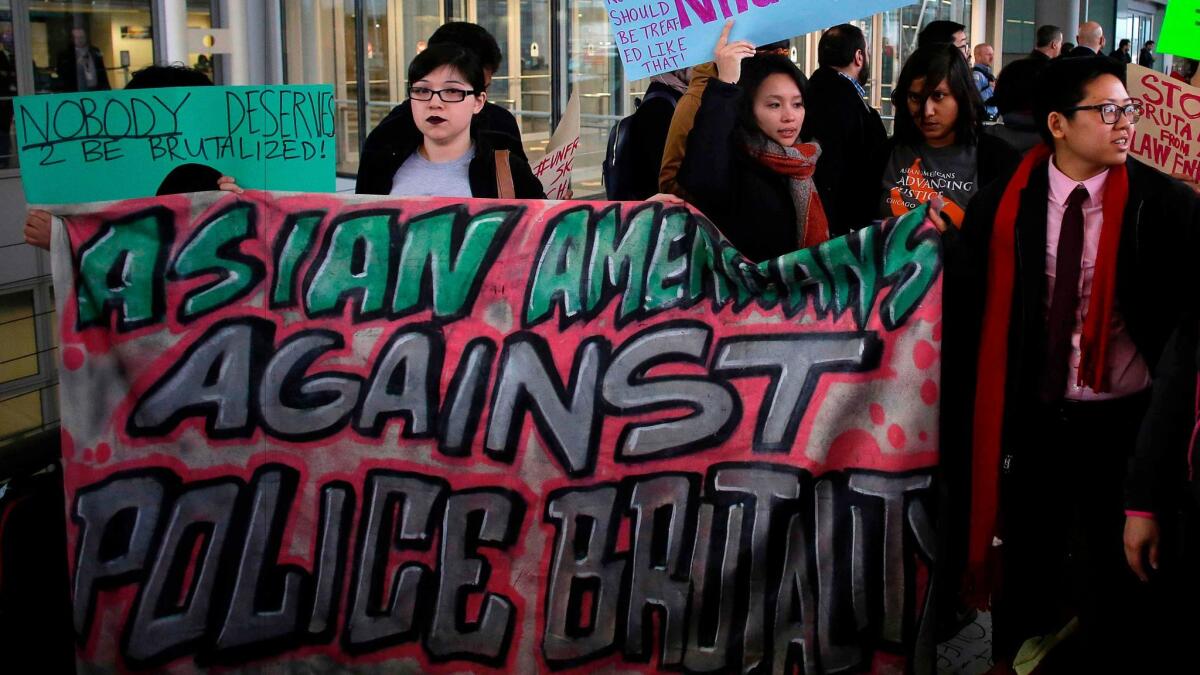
605;0;908;79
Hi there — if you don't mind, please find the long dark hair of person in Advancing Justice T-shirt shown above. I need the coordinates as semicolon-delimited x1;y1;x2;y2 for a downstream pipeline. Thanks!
892;43;983;145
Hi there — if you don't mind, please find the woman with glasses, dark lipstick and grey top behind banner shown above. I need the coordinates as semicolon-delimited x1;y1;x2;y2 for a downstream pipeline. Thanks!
355;42;546;199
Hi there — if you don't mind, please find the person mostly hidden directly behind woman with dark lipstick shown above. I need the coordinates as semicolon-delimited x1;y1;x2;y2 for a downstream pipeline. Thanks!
359;22;527;172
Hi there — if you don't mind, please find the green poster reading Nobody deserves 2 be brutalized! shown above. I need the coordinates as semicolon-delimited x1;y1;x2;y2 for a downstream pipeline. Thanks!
13;84;336;204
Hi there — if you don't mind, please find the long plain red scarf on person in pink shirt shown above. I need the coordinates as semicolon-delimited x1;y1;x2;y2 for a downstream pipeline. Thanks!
965;144;1129;609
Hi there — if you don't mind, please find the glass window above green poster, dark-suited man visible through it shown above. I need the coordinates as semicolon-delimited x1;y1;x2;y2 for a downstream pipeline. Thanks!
29;0;154;94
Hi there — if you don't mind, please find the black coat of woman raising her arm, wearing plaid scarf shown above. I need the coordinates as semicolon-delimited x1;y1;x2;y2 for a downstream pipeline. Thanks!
679;78;796;262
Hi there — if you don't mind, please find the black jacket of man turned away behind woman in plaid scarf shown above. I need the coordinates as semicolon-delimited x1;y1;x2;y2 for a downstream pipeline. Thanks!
802;67;888;237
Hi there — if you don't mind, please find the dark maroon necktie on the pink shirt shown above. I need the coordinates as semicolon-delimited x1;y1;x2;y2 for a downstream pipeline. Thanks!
1042;185;1087;402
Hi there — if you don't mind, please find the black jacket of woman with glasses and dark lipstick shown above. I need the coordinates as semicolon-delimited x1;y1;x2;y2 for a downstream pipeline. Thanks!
354;101;546;199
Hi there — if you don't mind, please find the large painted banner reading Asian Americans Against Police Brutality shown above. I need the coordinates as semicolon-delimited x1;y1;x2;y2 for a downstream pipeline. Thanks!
53;191;942;673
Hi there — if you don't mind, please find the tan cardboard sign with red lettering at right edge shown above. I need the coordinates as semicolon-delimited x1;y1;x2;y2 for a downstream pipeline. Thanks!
1126;65;1200;180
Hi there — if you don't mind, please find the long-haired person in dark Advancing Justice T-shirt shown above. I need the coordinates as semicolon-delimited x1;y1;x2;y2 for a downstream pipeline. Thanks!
880;42;1020;226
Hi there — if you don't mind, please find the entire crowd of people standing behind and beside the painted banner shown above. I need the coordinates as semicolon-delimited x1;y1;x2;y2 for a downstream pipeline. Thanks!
18;20;1200;673
